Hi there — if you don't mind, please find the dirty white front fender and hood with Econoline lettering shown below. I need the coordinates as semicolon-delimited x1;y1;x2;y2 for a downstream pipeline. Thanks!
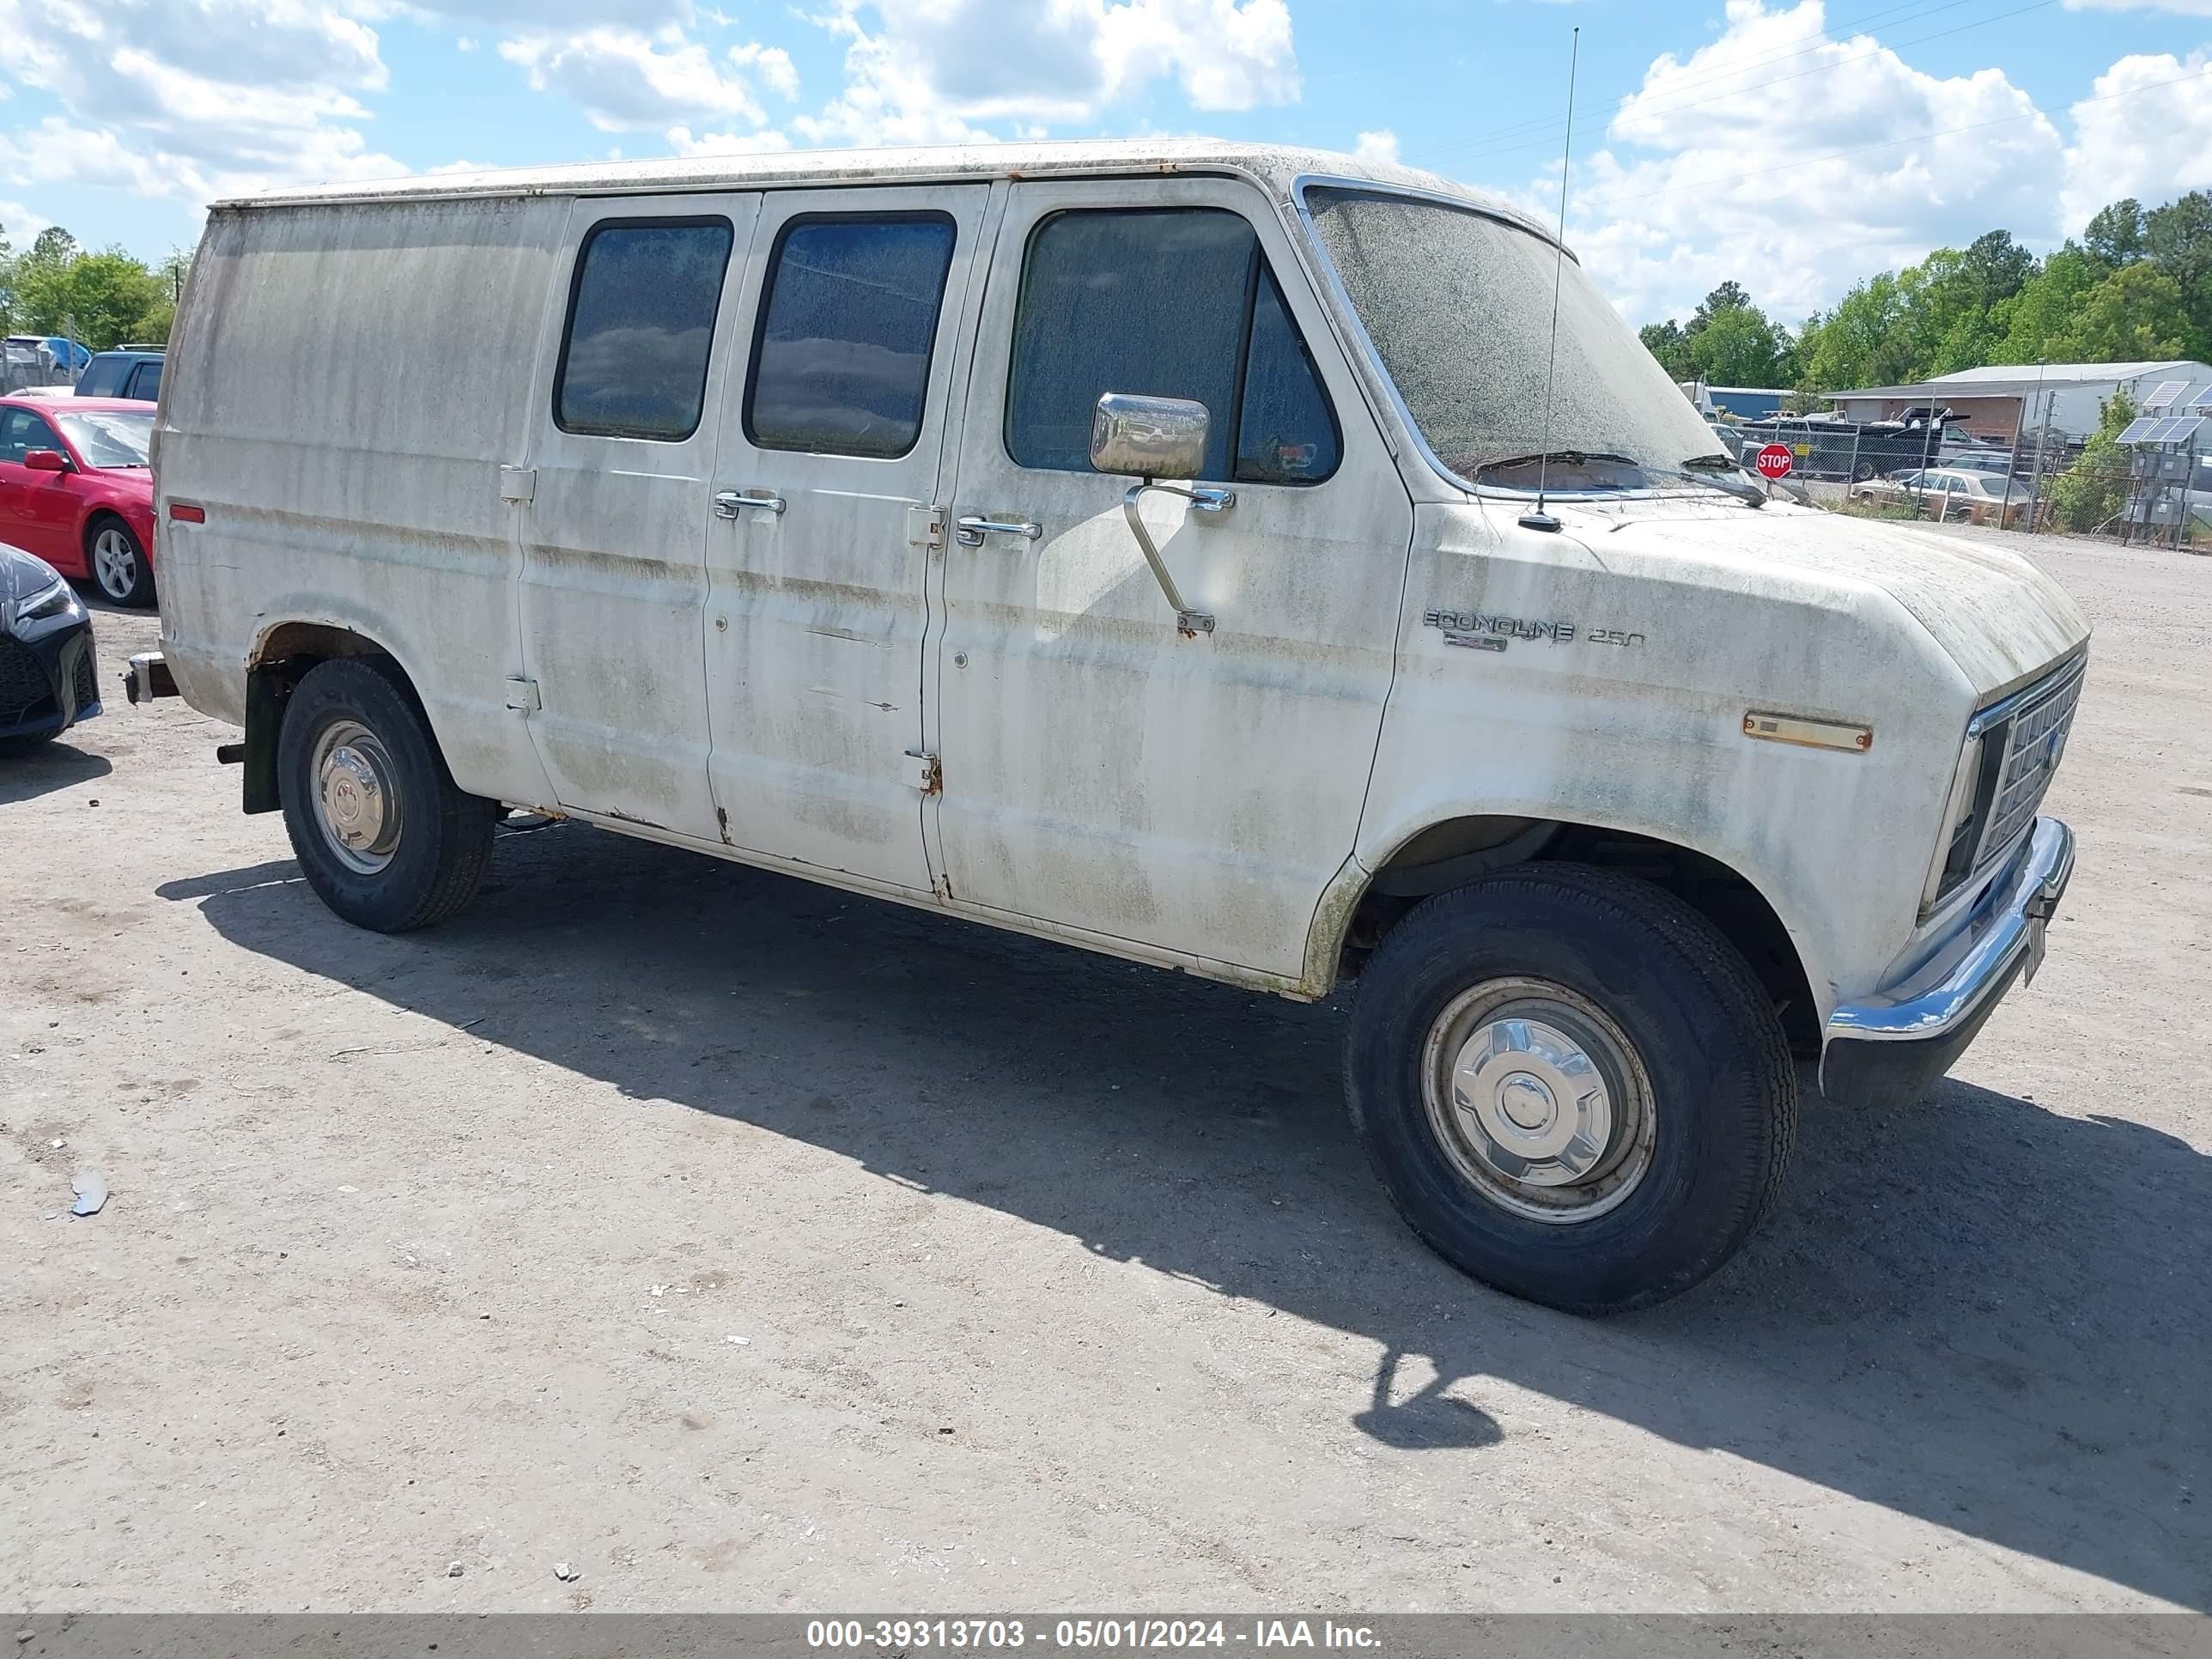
1358;495;2088;1018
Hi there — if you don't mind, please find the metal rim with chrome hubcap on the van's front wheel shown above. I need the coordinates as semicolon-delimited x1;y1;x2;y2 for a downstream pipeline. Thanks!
1422;980;1656;1224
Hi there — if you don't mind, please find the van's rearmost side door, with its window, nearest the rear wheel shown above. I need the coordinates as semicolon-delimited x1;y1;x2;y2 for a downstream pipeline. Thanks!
515;195;761;841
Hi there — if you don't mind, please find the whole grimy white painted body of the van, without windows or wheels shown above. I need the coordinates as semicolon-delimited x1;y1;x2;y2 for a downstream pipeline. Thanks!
157;143;2086;1015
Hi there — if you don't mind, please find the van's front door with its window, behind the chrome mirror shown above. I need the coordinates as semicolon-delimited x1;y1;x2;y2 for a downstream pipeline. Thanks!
931;179;1413;980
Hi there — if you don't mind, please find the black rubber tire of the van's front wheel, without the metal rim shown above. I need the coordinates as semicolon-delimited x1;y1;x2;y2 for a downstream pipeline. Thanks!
1345;865;1798;1314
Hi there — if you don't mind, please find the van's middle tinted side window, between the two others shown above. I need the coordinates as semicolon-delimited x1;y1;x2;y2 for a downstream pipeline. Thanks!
745;215;953;458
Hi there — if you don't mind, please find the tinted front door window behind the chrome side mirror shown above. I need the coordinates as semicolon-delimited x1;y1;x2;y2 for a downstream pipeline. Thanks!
1006;208;1343;484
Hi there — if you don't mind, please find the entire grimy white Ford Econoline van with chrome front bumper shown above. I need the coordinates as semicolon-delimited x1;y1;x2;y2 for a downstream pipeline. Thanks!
146;143;2088;1312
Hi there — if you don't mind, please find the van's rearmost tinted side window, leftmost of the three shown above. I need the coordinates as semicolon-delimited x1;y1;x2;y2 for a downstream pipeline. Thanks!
553;219;732;442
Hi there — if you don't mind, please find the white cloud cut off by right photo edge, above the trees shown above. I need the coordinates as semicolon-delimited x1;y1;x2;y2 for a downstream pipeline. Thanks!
2062;49;2212;234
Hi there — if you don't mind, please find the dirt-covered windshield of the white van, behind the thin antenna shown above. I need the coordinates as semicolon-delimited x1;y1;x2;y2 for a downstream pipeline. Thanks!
1305;188;1735;493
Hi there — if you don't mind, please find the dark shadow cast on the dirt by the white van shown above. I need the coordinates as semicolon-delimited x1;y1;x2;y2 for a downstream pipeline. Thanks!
159;825;2212;1608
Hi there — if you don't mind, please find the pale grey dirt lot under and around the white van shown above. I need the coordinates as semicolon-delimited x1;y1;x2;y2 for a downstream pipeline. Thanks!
0;528;2212;1613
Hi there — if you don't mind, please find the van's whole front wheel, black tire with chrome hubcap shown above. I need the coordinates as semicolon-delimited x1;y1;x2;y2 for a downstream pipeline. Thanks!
1345;865;1796;1314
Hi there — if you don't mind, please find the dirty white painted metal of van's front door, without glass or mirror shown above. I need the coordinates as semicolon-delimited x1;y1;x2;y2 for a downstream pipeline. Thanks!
931;179;1413;980
